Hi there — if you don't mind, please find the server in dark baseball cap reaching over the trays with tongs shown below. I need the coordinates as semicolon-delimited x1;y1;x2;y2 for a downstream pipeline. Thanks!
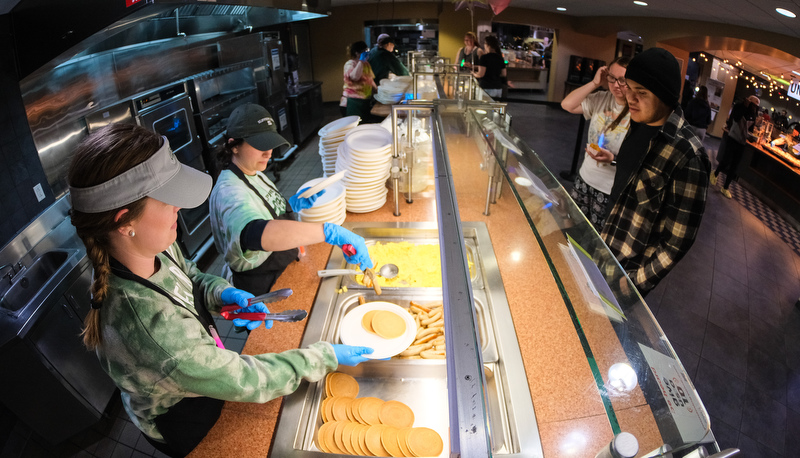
209;103;373;295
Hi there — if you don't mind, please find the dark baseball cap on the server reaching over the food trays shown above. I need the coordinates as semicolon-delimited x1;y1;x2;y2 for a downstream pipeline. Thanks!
228;103;289;151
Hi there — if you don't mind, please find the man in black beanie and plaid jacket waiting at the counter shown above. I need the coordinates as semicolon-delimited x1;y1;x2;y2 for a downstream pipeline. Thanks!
601;48;711;295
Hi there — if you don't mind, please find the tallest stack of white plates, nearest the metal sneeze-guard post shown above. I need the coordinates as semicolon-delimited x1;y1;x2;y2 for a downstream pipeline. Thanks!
336;124;392;213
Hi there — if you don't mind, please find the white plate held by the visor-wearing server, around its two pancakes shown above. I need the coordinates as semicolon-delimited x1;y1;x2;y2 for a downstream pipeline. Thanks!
339;301;417;359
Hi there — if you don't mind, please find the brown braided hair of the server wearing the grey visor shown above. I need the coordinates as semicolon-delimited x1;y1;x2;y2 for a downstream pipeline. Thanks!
67;124;161;350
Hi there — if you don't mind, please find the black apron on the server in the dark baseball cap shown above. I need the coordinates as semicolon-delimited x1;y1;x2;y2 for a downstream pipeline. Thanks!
228;164;300;296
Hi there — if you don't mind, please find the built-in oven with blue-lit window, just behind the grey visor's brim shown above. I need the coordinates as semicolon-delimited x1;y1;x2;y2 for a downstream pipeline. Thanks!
132;82;216;258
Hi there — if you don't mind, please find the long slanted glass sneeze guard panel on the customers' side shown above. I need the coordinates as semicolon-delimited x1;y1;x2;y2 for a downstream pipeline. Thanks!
462;107;713;452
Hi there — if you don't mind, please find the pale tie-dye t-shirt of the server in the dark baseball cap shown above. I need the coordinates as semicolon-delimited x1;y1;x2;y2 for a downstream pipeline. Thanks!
209;166;288;280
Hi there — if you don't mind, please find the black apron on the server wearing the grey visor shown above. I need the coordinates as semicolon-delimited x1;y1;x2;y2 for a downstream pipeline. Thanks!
109;251;225;457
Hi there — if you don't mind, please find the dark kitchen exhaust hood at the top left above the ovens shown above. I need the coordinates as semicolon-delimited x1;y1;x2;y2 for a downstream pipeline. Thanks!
9;0;330;78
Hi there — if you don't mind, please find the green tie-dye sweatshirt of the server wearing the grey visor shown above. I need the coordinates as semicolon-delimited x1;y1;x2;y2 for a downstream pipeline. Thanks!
97;244;337;440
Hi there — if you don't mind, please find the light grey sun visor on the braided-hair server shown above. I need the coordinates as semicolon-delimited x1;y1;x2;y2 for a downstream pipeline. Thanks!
69;136;213;213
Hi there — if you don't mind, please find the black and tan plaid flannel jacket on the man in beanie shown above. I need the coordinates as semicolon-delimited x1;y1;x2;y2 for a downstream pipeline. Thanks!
601;107;711;294
